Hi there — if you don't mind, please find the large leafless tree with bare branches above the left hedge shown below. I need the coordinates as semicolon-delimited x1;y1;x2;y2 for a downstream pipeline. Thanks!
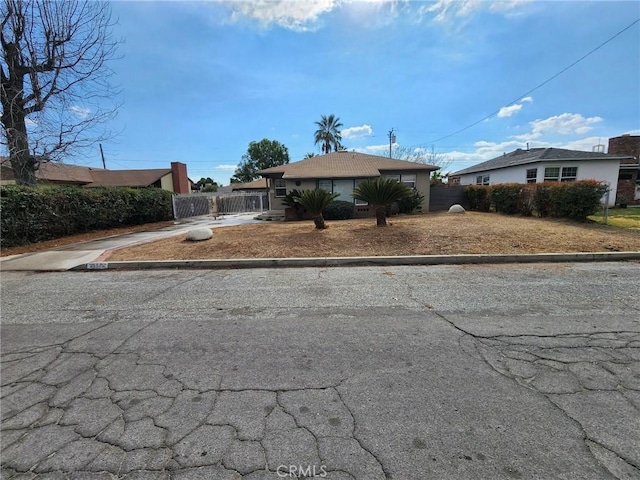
0;0;119;185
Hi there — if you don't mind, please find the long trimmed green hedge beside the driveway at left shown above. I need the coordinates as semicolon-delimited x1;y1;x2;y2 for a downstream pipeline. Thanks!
0;185;173;248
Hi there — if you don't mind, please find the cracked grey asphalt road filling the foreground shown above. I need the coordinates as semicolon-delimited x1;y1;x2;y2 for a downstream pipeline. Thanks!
1;263;640;480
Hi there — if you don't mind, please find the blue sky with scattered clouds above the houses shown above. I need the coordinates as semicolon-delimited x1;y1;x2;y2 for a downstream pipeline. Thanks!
87;0;640;184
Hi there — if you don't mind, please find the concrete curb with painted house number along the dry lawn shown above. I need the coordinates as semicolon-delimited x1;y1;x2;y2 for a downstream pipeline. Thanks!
71;252;640;271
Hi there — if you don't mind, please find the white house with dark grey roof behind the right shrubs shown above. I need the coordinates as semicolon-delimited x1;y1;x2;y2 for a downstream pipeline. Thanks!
449;148;633;206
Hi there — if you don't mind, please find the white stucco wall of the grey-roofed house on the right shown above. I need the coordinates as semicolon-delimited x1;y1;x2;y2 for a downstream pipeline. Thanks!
460;160;620;206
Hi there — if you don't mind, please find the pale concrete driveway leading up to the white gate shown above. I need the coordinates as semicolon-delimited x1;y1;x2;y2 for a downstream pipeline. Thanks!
0;213;258;271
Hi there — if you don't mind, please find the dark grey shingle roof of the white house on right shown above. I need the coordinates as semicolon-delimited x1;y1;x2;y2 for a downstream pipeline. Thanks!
450;148;633;176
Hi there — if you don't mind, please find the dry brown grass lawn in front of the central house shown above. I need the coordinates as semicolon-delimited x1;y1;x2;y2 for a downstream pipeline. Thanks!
108;212;640;261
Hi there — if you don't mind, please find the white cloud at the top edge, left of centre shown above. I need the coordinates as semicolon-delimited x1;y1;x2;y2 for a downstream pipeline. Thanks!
227;0;339;31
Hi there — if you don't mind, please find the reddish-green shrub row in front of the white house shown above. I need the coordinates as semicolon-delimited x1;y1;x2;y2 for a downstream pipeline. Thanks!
466;180;607;221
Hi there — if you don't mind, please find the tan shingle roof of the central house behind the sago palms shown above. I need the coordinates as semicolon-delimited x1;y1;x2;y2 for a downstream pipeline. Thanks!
258;150;440;178
